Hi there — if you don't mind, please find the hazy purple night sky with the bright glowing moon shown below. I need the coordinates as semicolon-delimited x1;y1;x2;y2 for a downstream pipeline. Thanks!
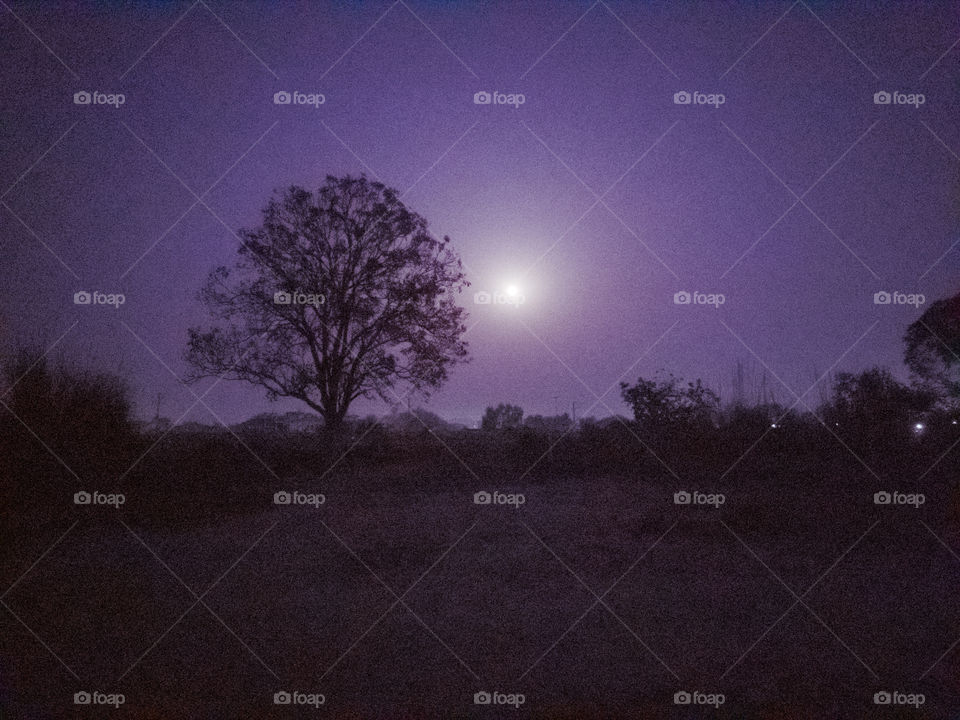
0;0;960;422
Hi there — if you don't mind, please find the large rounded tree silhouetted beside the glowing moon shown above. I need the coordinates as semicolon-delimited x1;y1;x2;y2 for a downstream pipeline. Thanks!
186;176;469;427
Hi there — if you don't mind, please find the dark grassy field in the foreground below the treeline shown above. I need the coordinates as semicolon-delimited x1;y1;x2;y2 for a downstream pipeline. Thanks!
0;424;960;719
